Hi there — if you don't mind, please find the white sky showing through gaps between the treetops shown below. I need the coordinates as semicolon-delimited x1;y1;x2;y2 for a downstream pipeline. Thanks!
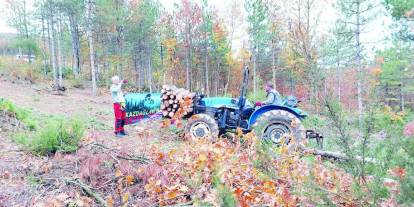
0;0;392;55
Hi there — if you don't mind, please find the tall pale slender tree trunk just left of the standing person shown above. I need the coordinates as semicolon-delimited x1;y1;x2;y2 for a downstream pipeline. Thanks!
86;0;97;96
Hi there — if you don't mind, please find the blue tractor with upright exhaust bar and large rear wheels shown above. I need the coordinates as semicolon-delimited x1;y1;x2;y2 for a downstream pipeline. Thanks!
185;67;319;145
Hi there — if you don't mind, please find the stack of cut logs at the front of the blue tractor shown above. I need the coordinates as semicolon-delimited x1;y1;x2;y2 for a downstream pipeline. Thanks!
161;85;195;119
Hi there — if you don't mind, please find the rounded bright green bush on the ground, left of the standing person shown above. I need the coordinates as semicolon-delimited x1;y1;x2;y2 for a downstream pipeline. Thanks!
16;119;85;155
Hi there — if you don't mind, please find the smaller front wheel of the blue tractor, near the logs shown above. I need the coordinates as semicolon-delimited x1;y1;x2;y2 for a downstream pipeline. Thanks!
185;114;219;141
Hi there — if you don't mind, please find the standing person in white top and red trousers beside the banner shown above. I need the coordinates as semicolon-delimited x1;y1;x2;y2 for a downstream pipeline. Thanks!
111;76;127;137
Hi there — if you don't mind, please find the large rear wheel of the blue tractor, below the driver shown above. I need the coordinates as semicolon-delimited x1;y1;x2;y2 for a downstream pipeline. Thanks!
253;110;306;149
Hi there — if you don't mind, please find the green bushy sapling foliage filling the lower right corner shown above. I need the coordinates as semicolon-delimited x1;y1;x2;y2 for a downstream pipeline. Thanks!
324;101;414;205
